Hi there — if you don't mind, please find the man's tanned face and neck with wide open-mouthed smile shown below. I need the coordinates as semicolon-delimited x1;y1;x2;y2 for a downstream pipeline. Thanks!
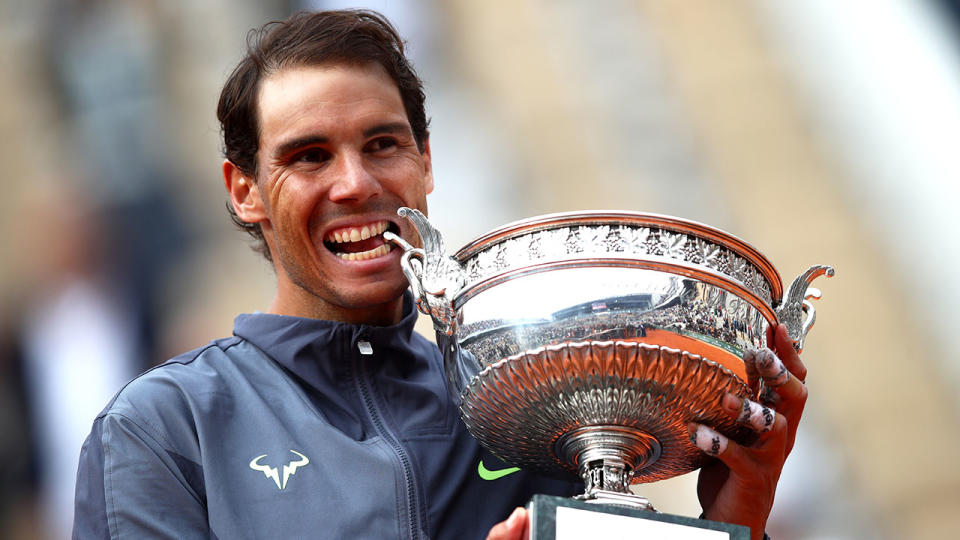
248;64;433;324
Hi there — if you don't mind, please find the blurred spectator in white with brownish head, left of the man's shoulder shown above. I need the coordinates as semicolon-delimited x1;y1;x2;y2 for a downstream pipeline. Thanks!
11;185;143;538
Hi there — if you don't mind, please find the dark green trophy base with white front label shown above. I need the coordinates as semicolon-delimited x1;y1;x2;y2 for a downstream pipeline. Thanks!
528;495;750;540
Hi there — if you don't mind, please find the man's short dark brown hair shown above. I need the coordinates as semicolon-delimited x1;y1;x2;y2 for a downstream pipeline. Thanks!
217;10;429;260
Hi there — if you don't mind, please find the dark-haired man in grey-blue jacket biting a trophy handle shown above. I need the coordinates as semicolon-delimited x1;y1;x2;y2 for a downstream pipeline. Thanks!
74;11;805;538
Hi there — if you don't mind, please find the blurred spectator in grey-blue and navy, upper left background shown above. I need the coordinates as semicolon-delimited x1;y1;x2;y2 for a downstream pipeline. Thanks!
49;0;189;367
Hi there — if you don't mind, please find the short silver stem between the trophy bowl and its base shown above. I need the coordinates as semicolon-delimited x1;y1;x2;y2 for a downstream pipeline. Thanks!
556;425;660;510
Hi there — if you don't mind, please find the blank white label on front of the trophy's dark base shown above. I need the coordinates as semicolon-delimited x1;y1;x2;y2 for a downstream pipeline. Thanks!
556;506;730;540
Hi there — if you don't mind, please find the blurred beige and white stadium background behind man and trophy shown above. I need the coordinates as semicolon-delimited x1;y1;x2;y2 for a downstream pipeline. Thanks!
0;0;960;539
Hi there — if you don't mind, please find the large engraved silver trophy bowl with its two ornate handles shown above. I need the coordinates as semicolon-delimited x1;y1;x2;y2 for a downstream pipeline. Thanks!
388;208;833;499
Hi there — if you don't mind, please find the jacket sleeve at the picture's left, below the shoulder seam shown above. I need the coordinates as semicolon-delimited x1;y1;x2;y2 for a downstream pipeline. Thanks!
73;413;213;540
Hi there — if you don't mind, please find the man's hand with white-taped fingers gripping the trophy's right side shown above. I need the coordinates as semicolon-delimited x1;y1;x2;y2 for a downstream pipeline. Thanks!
688;324;807;539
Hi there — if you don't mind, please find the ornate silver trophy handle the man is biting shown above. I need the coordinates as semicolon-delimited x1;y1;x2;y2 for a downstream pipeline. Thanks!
383;207;466;336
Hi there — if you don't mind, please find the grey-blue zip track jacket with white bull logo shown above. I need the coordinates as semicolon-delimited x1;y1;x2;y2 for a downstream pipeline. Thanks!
73;296;582;539
